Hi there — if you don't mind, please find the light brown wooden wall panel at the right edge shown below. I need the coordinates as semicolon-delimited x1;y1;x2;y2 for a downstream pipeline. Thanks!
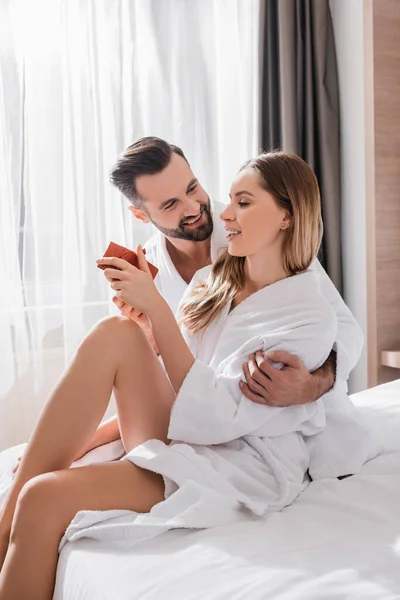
373;0;400;383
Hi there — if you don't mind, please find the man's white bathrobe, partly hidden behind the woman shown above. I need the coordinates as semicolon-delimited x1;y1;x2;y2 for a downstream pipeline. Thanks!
146;202;379;479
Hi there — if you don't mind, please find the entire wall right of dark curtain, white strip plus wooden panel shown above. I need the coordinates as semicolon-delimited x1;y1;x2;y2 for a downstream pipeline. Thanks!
330;0;400;391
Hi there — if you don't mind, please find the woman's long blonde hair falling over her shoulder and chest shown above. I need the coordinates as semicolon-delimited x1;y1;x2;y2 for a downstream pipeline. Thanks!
180;152;322;333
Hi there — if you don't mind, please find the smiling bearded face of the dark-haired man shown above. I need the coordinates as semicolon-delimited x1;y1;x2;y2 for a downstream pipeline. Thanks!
132;152;213;242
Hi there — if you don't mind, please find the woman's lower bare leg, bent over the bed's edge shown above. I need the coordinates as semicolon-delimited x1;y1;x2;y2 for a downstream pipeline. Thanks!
0;461;164;600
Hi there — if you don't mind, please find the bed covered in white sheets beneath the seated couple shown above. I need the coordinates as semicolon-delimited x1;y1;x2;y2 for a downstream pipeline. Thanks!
0;380;400;600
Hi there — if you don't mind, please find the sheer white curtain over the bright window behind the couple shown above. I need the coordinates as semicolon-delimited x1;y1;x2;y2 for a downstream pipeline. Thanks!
0;0;259;449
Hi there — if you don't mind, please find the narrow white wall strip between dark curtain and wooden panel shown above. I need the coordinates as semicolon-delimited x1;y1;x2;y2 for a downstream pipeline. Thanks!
330;0;368;392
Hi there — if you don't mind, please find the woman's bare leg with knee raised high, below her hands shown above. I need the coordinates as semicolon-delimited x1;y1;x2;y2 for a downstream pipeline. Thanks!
0;317;175;570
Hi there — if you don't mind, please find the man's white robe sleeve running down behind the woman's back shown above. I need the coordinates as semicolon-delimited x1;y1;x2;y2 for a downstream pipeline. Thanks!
312;260;364;387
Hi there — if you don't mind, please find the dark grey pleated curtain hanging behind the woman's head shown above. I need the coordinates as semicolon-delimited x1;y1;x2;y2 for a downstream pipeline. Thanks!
261;0;342;291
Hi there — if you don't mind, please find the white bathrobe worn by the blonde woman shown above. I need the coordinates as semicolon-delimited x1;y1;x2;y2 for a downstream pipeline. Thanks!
57;267;337;546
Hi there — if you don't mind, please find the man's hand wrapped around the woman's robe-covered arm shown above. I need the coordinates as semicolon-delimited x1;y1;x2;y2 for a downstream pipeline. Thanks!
239;350;336;407
